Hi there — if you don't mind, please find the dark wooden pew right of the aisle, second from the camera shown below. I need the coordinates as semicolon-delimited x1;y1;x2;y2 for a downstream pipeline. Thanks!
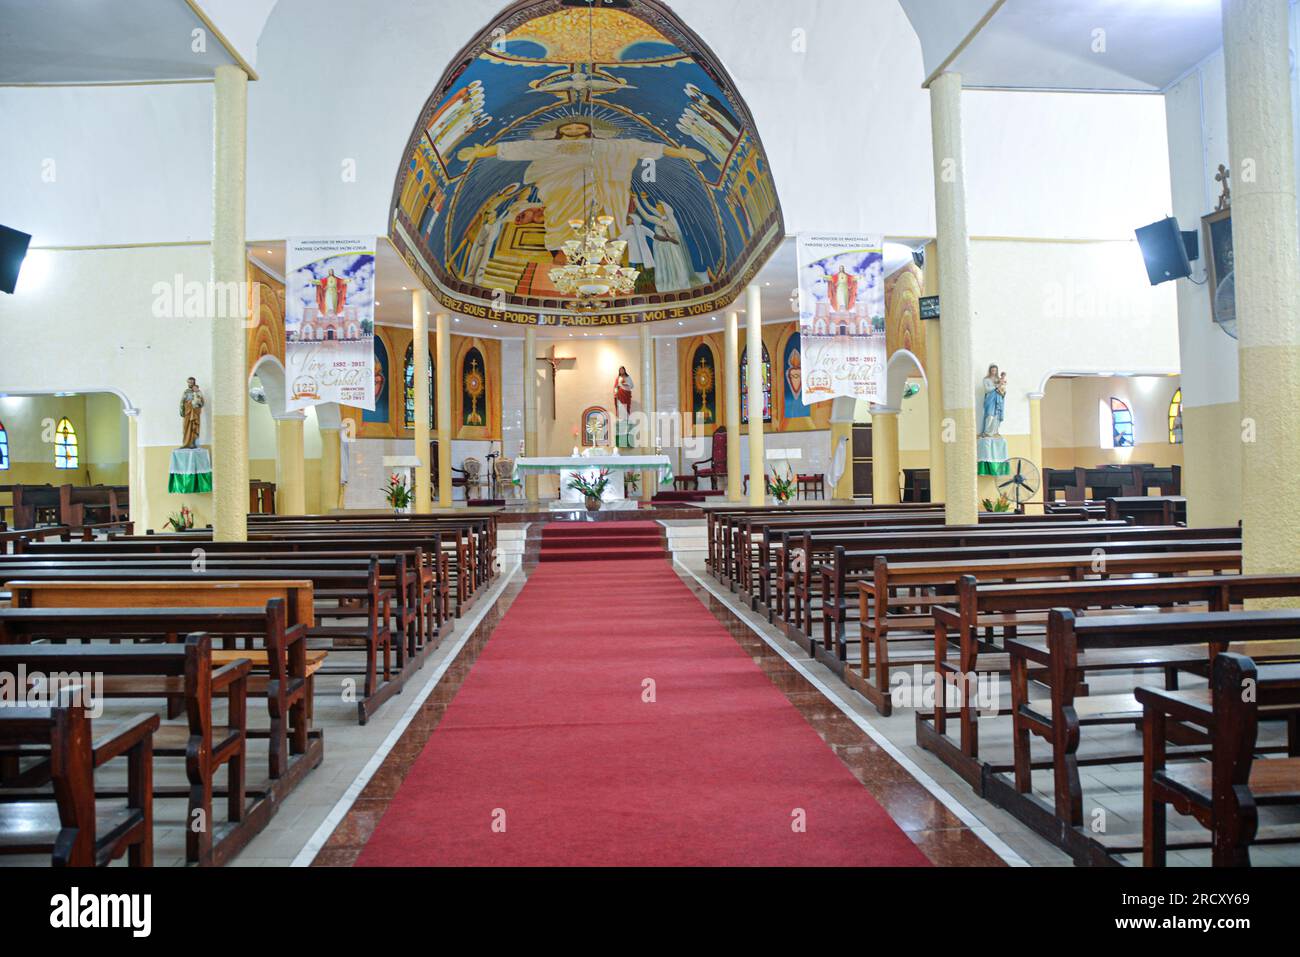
985;609;1300;861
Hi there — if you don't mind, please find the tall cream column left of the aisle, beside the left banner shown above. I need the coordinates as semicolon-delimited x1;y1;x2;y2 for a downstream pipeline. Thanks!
209;65;248;542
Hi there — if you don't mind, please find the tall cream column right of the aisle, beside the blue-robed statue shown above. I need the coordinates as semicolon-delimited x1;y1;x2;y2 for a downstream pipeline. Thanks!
930;73;979;525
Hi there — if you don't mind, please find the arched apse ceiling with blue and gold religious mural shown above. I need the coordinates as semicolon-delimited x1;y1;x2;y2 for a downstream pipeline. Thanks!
390;0;784;325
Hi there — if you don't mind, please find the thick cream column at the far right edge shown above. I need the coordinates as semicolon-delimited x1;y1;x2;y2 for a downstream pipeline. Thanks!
1223;0;1300;573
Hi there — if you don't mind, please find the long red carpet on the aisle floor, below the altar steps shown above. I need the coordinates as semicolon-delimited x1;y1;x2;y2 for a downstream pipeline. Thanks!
358;523;927;866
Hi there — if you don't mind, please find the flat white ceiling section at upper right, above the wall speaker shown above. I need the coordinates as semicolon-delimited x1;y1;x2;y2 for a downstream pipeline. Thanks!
900;0;1223;92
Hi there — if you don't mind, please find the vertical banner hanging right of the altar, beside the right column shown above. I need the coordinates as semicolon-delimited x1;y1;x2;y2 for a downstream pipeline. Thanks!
798;233;888;406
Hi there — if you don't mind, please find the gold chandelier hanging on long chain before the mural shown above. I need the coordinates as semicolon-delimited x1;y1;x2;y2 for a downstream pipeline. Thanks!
550;0;641;304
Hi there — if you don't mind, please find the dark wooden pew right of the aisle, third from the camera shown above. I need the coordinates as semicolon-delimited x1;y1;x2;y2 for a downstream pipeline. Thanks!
917;575;1300;791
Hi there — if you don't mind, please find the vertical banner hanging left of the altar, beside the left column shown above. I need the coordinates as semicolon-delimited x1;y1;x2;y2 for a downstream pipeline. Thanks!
285;237;377;411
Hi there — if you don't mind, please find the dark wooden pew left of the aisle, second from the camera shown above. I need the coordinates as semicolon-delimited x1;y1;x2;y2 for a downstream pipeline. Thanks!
0;635;251;863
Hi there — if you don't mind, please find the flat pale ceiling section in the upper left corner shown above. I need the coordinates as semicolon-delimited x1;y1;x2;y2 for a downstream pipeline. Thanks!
0;0;248;85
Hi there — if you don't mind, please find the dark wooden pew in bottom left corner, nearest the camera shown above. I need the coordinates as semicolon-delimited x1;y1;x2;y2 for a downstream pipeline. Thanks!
0;707;159;867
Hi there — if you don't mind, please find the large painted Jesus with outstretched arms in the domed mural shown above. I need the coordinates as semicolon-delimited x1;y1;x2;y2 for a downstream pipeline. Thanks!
458;120;705;254
